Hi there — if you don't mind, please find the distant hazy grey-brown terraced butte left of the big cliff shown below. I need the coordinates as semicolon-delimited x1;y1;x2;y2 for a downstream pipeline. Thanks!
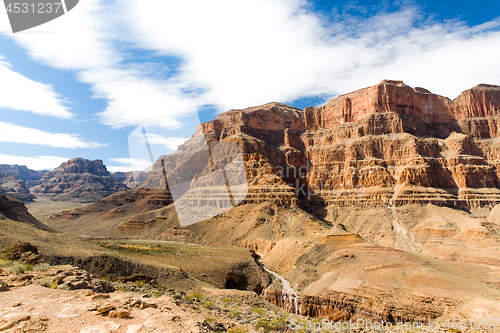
31;158;128;202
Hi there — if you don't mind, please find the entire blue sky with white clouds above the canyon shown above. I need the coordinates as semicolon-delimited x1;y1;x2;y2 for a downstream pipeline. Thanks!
0;0;500;171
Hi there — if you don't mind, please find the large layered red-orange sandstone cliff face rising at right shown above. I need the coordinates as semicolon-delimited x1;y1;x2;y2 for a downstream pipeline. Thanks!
143;80;500;208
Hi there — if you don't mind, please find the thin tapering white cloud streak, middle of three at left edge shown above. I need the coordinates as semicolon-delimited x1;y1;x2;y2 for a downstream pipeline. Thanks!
0;122;106;149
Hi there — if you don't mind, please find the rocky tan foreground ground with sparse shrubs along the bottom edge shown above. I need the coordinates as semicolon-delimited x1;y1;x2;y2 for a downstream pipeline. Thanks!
0;261;484;333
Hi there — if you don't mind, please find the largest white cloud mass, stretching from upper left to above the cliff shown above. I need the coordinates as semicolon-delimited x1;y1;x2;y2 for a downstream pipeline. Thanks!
3;0;500;135
